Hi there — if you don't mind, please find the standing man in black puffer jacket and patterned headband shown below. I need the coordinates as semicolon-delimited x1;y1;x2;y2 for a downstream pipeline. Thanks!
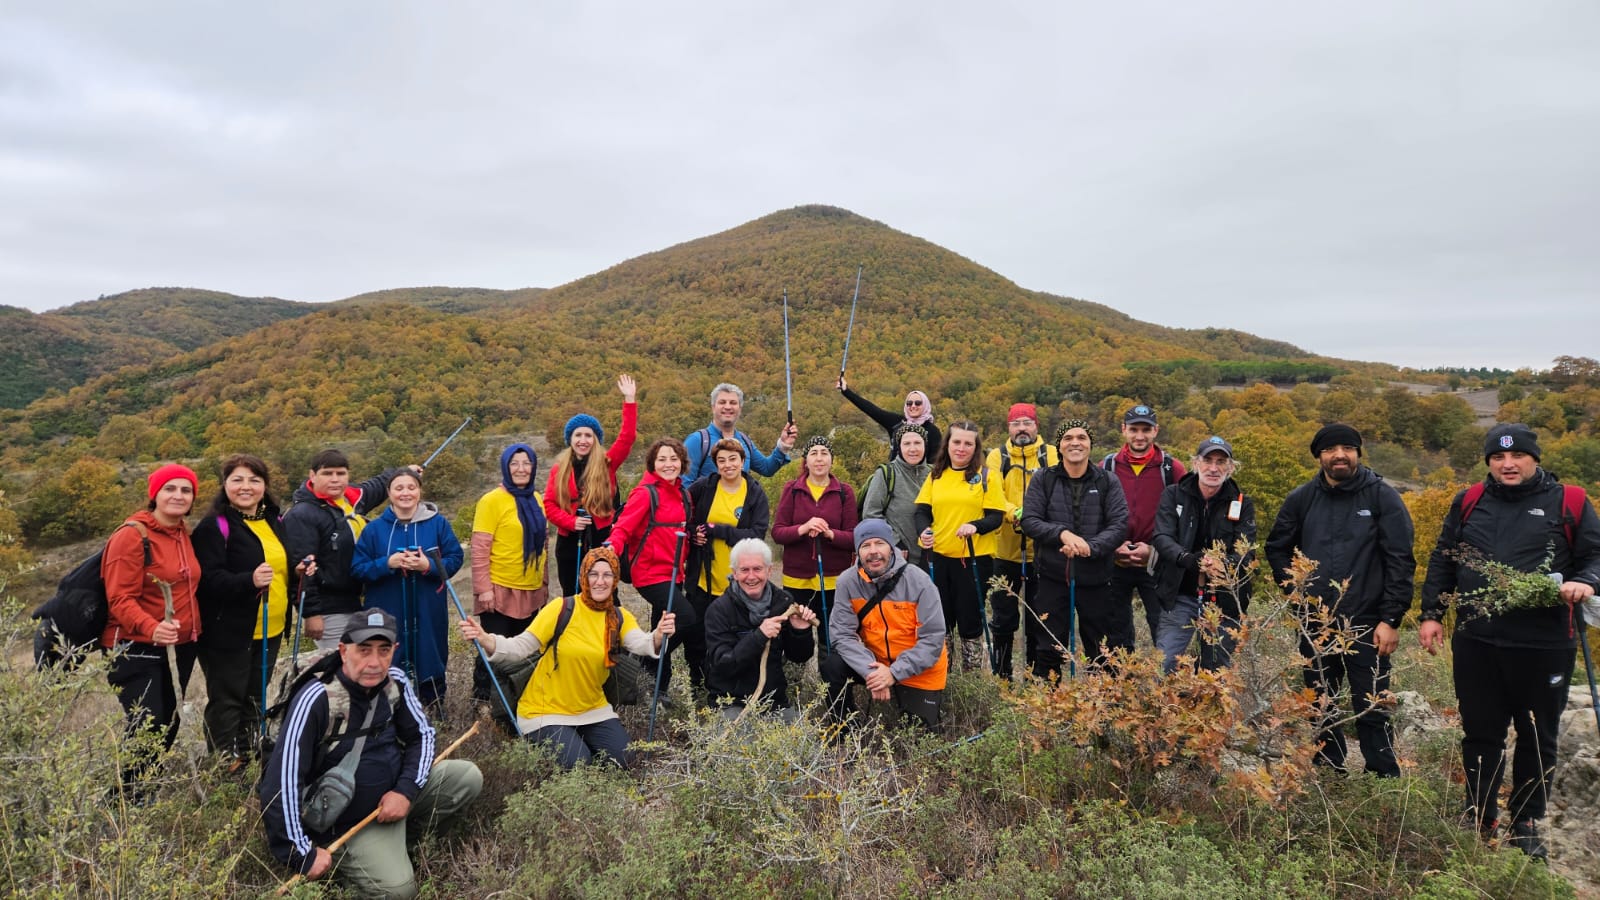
1022;420;1133;677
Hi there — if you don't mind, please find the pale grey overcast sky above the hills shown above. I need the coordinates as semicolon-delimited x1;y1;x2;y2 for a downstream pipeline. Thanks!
0;0;1600;367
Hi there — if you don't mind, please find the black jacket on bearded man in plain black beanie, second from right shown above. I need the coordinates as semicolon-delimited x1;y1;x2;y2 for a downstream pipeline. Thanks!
1267;466;1416;628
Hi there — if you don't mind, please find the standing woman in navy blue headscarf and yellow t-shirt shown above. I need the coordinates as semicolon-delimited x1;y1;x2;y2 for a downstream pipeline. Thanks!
472;444;550;701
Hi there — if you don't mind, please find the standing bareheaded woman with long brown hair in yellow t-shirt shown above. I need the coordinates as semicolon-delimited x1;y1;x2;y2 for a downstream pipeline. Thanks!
914;420;1006;671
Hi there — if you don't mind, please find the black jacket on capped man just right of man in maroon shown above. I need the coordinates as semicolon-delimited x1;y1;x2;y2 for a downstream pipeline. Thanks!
1150;472;1256;618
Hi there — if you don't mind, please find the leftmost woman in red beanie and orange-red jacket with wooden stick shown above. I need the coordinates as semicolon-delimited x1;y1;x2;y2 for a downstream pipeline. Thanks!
101;463;200;786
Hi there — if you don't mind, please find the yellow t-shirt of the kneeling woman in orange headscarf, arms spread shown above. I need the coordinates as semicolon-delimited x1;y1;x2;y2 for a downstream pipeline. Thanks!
517;597;638;719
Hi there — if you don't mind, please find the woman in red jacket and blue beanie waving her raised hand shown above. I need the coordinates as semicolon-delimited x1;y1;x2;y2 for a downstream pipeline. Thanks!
544;368;638;597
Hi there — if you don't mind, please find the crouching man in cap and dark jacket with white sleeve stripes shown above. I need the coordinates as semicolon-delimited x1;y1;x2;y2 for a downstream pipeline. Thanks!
259;610;483;897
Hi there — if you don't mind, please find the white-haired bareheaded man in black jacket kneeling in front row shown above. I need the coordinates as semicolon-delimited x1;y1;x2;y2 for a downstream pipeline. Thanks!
706;538;816;721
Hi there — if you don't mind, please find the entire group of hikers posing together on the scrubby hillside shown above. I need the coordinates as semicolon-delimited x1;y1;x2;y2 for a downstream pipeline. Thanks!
43;366;1600;895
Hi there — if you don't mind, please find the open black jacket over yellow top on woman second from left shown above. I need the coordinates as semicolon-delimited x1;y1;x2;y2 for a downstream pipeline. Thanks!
189;504;299;650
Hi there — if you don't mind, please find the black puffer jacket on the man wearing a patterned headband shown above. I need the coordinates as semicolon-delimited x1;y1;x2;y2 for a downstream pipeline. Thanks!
1022;464;1128;585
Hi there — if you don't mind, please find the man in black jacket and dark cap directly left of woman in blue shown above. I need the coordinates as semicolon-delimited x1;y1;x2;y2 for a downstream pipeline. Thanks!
283;450;422;650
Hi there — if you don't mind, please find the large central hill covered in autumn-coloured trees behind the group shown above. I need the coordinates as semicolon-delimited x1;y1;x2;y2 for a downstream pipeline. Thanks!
0;207;1376;464
